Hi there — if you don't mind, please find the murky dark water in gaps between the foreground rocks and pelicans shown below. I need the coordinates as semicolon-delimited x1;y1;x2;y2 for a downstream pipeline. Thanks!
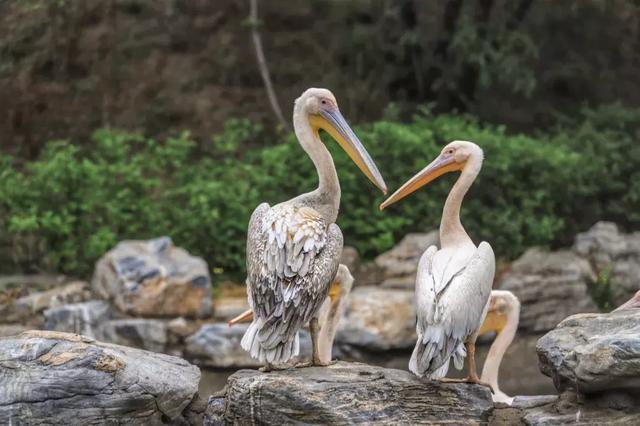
200;336;556;395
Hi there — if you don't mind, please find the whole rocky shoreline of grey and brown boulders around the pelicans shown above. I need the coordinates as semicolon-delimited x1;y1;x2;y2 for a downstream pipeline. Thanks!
0;223;640;425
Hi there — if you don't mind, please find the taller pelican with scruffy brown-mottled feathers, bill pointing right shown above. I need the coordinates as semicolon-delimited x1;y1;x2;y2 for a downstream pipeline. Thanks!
241;89;387;371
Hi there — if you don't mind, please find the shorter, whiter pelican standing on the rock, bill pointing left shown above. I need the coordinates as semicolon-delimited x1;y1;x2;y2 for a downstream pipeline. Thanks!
380;141;495;385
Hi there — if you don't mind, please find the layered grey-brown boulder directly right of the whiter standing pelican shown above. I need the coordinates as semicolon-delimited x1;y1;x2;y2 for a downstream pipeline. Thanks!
498;248;598;333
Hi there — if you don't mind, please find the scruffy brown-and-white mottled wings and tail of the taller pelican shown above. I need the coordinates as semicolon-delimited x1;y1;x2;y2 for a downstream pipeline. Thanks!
245;204;343;362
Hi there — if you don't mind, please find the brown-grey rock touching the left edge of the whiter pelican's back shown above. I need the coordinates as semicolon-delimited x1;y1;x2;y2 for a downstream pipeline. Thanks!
375;230;440;289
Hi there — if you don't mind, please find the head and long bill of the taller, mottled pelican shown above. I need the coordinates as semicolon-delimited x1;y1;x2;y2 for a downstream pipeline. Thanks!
295;88;387;194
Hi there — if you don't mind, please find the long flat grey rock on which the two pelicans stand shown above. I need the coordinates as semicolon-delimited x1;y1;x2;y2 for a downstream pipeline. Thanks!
218;362;493;424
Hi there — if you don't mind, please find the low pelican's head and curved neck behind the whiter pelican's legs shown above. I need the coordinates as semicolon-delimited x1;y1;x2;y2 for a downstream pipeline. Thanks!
478;290;520;405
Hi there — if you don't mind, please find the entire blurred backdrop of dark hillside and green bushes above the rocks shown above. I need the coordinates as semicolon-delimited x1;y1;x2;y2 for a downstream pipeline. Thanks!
0;0;640;279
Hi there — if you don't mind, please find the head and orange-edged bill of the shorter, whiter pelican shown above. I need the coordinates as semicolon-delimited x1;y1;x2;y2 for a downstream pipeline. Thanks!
380;141;484;210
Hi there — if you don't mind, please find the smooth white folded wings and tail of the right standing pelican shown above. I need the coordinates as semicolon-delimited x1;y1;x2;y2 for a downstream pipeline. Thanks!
409;242;495;378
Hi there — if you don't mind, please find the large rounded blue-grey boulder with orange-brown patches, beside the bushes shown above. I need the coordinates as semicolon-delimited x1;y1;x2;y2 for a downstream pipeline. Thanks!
91;237;211;318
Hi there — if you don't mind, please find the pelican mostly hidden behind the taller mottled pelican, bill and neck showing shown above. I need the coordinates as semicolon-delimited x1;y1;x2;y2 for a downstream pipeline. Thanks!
229;264;353;364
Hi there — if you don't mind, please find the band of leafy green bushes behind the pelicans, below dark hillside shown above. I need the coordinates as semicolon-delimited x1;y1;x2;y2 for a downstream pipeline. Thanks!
0;110;640;278
